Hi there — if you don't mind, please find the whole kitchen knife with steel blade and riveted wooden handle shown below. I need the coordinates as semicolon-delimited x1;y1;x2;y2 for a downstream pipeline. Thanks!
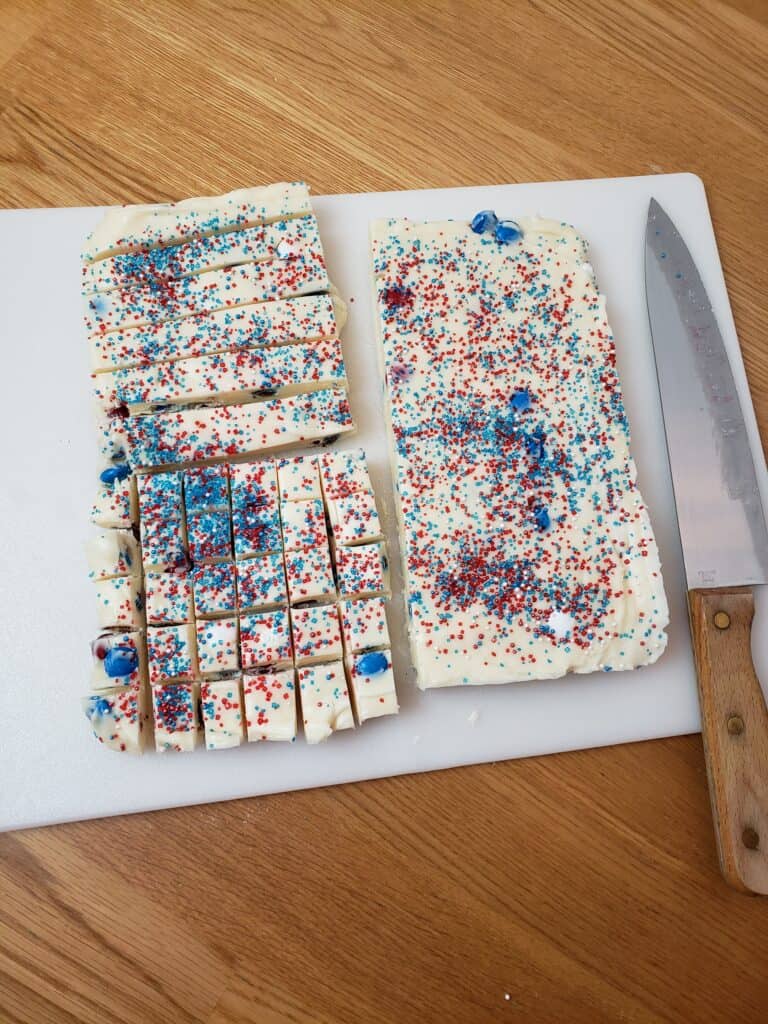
645;199;768;894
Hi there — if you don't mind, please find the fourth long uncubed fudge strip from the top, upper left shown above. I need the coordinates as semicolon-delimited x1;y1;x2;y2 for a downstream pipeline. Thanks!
90;295;342;373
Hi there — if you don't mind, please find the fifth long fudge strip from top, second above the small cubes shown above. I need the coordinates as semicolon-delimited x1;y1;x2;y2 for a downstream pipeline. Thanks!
91;338;346;413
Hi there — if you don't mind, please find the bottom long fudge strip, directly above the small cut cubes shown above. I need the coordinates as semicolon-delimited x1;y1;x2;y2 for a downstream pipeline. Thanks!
123;388;352;468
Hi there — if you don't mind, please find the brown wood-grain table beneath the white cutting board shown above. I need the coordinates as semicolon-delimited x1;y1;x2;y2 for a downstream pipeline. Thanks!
0;0;768;1024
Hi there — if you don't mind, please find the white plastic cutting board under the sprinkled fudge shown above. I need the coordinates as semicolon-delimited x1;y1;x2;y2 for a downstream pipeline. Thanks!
0;174;768;829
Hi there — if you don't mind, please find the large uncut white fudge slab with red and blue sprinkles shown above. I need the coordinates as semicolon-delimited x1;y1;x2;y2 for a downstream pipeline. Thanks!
372;211;668;687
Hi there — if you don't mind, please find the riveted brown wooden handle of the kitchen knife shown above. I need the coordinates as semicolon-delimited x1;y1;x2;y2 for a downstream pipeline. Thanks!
688;587;768;894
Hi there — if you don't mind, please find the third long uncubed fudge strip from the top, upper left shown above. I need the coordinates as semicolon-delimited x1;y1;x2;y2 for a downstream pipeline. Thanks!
85;250;331;335
